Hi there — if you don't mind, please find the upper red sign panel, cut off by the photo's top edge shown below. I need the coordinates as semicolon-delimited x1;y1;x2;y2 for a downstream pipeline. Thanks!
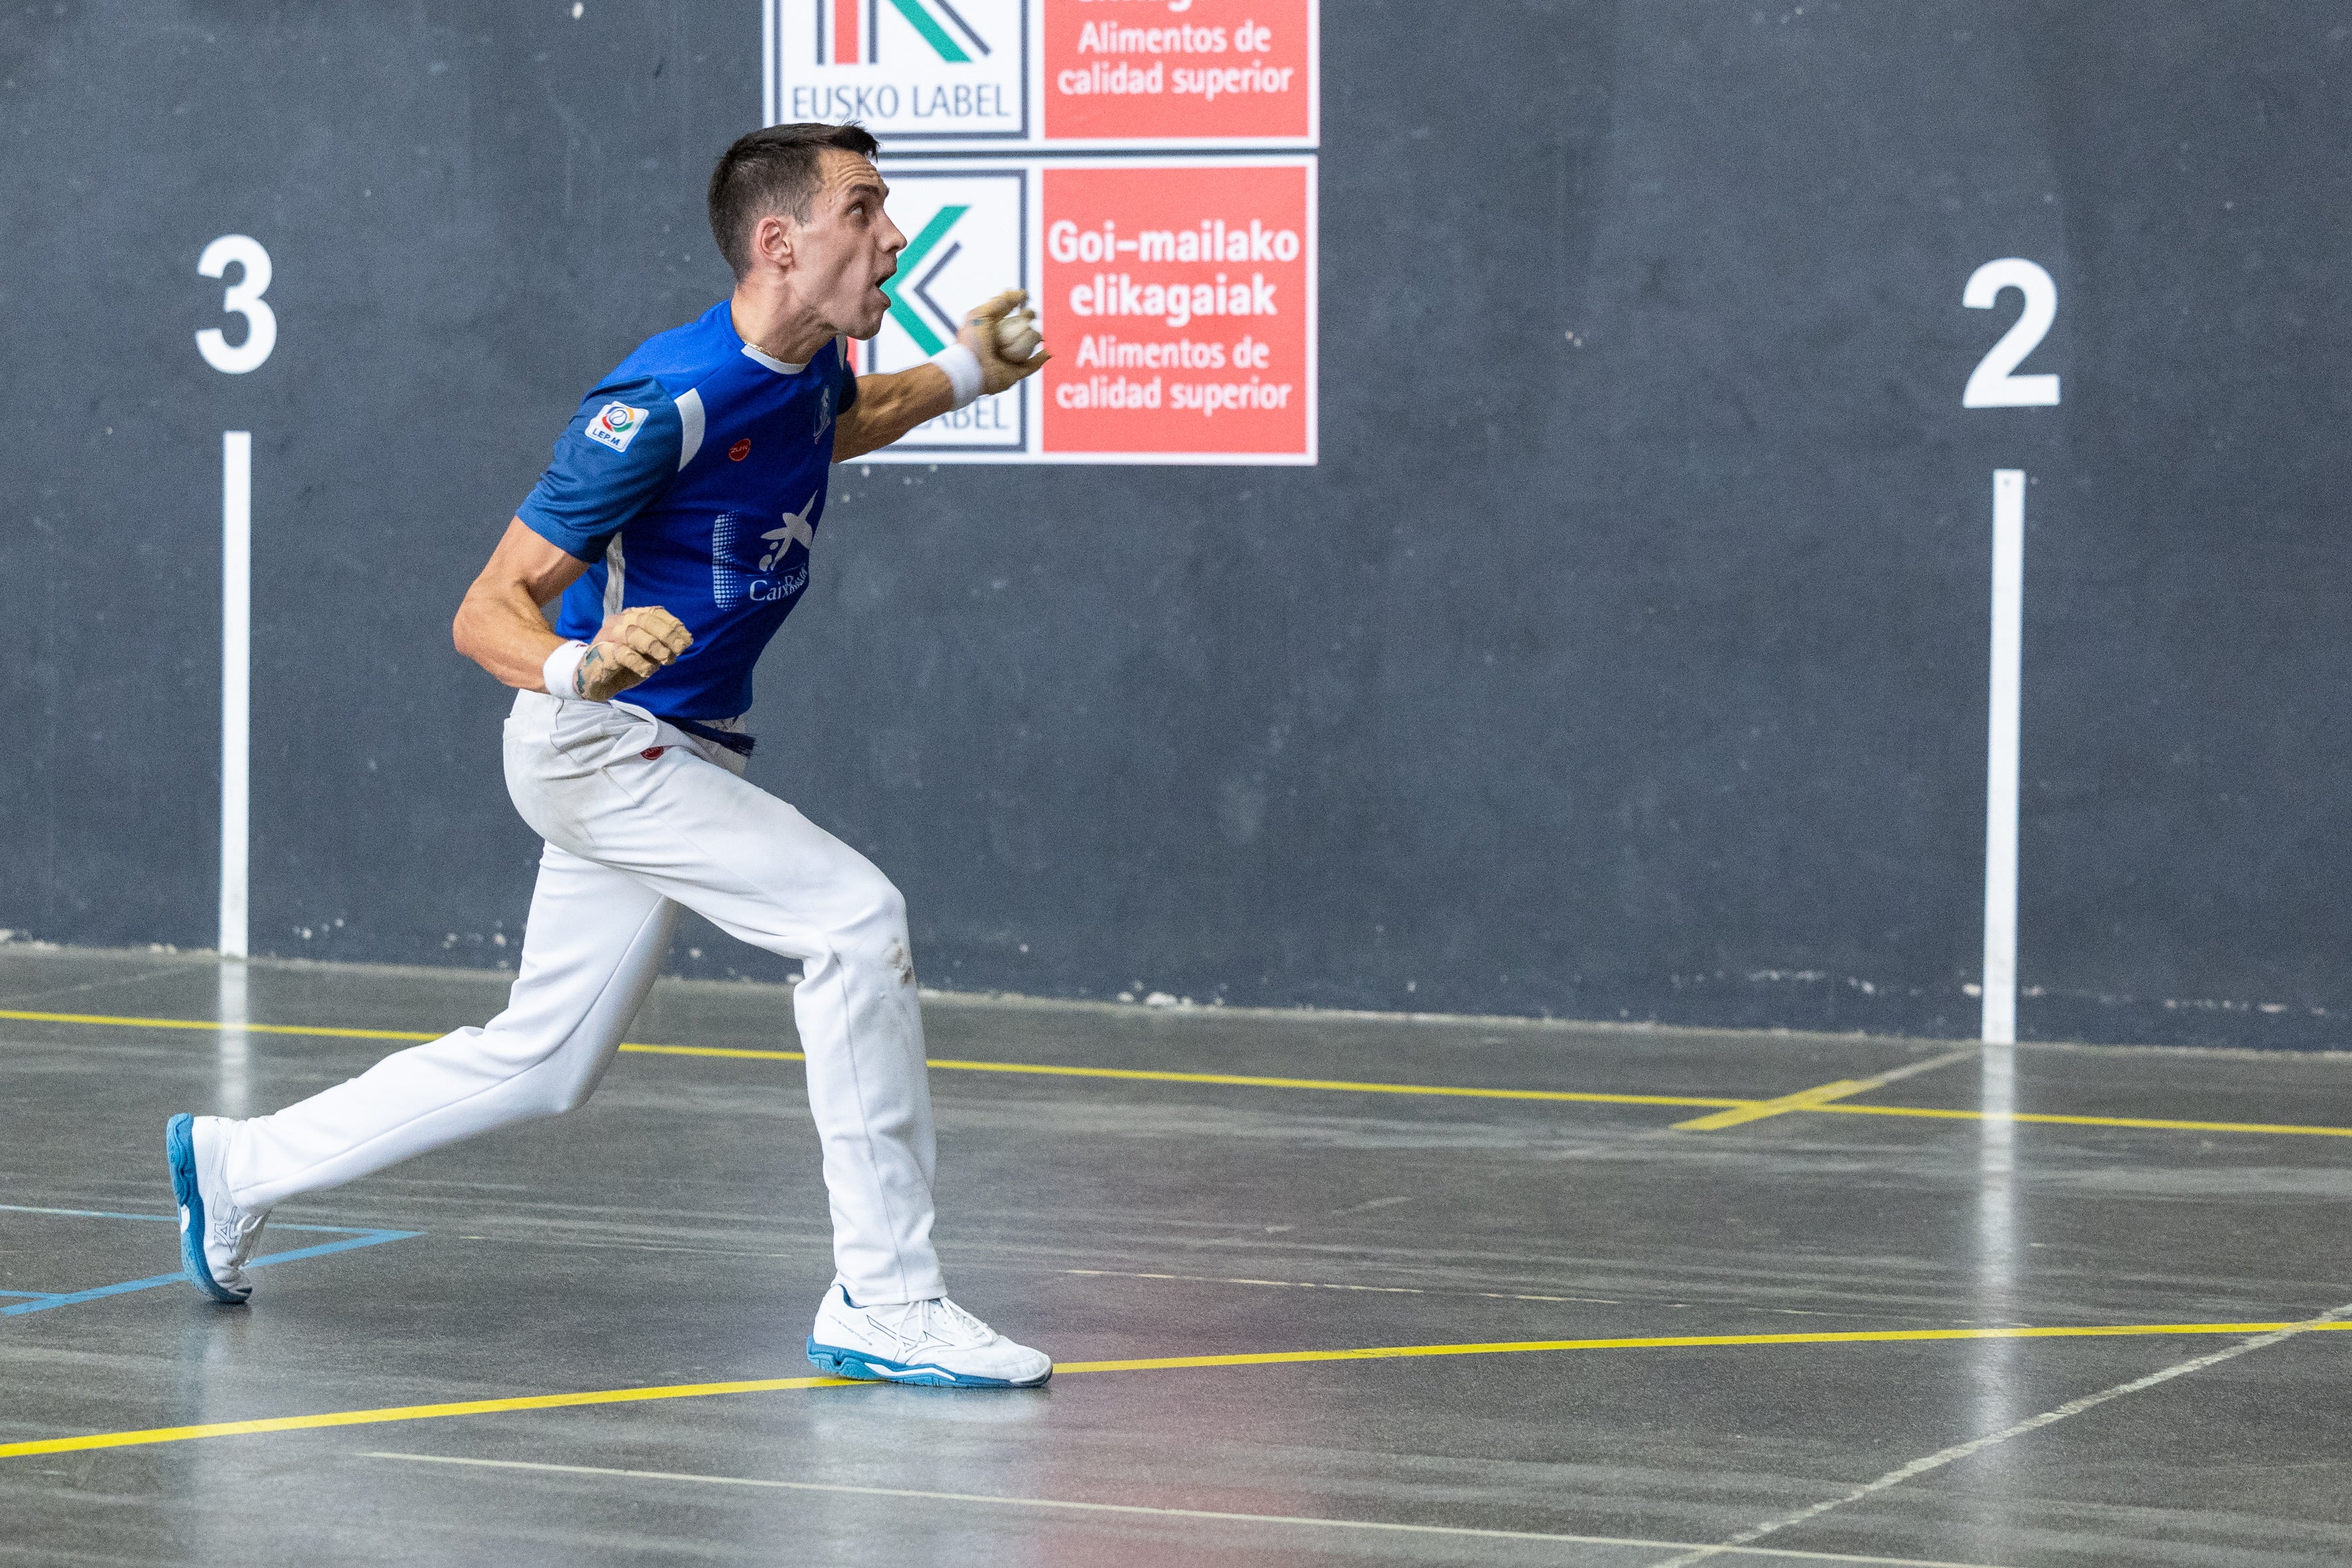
1040;0;1317;146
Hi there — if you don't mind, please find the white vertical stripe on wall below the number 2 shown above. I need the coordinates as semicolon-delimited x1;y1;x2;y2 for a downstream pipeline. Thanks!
1985;468;2025;1046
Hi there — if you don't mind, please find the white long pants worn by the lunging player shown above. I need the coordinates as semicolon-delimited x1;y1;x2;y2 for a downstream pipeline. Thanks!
228;691;945;1302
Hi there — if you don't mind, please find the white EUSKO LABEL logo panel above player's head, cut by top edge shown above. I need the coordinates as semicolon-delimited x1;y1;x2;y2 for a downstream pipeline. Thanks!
769;0;1030;146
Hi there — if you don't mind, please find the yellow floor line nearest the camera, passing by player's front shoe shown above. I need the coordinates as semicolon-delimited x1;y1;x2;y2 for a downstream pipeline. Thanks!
0;1321;2352;1460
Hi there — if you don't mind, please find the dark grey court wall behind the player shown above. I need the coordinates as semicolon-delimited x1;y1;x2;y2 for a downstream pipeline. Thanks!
0;0;2352;1046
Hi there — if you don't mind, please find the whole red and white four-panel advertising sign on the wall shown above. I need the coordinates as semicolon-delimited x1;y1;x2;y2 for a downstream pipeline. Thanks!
764;0;1322;463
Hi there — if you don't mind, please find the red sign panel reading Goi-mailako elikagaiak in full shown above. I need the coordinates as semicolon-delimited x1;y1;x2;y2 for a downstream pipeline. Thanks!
1037;162;1315;463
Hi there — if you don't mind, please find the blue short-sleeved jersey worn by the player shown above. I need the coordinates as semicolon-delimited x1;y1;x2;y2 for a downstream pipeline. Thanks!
517;301;858;720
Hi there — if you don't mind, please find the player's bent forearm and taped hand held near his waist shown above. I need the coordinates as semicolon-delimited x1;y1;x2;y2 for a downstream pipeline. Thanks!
449;517;694;703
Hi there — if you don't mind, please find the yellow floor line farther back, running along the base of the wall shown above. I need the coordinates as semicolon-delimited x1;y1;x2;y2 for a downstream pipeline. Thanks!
0;1008;2352;1138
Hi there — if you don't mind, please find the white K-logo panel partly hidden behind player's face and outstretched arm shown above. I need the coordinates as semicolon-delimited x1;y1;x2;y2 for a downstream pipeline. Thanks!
856;165;1030;453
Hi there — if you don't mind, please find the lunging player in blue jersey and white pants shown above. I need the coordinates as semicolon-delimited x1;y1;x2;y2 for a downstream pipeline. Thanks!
165;125;1054;1387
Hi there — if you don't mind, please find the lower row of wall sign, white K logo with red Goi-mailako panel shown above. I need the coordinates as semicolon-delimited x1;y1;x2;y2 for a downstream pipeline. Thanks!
858;155;1315;463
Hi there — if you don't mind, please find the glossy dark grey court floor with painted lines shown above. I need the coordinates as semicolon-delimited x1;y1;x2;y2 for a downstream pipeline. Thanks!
0;947;2352;1568
